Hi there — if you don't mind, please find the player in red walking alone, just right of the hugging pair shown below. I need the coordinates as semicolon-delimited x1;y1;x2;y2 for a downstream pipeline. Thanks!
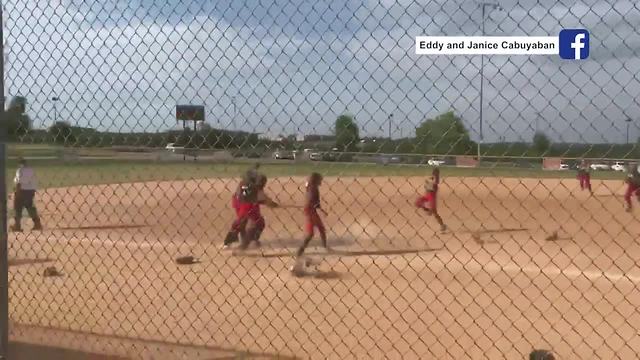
290;172;330;272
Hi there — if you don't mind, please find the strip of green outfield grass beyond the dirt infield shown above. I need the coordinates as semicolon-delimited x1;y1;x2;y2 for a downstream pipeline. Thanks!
1;160;624;188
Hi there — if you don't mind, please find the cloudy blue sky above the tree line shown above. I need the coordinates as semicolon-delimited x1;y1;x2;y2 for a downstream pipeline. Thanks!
4;0;640;142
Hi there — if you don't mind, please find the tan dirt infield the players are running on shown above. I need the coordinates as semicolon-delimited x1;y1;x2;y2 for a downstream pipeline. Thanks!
9;177;640;359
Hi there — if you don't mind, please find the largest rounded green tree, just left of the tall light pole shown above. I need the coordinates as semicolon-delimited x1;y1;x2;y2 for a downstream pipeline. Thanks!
415;111;474;155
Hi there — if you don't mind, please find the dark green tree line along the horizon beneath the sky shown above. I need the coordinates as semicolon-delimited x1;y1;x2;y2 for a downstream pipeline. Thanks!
4;96;640;159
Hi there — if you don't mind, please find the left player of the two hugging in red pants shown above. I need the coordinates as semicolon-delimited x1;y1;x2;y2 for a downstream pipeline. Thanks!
223;166;258;249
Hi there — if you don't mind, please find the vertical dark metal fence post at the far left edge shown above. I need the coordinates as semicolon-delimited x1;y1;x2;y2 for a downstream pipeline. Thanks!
0;0;9;359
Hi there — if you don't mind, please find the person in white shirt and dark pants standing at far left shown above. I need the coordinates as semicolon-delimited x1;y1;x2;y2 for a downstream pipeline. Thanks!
11;158;42;232
